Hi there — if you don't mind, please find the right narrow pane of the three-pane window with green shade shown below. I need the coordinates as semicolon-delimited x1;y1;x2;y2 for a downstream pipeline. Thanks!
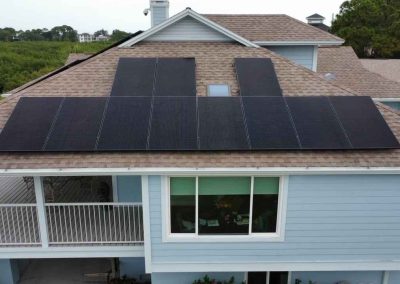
252;177;279;233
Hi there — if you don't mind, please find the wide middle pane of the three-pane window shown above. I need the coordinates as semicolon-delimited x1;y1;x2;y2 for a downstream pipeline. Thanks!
198;177;251;235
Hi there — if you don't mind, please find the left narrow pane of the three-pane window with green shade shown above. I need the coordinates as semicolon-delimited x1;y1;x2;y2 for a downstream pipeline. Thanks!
170;177;196;233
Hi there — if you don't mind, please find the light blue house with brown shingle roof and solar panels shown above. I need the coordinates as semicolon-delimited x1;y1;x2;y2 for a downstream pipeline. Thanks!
0;1;400;284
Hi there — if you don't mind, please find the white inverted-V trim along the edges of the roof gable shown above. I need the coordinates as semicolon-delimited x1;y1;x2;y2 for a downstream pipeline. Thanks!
119;8;259;48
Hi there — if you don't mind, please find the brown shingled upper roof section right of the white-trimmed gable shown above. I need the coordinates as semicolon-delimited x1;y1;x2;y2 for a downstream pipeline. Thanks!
204;14;344;44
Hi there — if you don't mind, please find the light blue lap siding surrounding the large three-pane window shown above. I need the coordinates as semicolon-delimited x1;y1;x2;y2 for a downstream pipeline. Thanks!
149;175;400;262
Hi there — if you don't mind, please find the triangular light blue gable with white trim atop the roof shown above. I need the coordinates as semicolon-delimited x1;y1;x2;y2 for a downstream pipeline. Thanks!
119;8;259;47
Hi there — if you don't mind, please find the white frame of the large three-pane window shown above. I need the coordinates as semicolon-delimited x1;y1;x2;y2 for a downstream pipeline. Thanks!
161;175;288;243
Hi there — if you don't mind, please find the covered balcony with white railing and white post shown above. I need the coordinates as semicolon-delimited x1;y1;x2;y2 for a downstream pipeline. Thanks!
0;177;144;255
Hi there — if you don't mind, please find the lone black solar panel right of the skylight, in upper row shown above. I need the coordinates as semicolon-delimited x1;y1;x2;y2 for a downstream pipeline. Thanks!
235;58;282;96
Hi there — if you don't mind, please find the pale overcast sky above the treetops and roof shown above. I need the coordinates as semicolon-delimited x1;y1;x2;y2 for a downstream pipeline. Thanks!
0;0;344;33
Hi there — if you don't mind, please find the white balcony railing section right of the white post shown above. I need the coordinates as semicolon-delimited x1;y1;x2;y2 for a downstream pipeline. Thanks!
45;203;143;245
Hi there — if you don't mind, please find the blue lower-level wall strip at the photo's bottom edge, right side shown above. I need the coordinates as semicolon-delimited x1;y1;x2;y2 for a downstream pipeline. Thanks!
291;271;383;284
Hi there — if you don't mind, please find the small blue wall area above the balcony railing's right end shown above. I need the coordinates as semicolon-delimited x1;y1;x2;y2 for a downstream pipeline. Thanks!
117;176;142;202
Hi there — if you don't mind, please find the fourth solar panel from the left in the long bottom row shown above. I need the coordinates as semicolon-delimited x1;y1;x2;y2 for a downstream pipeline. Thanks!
149;97;198;150
